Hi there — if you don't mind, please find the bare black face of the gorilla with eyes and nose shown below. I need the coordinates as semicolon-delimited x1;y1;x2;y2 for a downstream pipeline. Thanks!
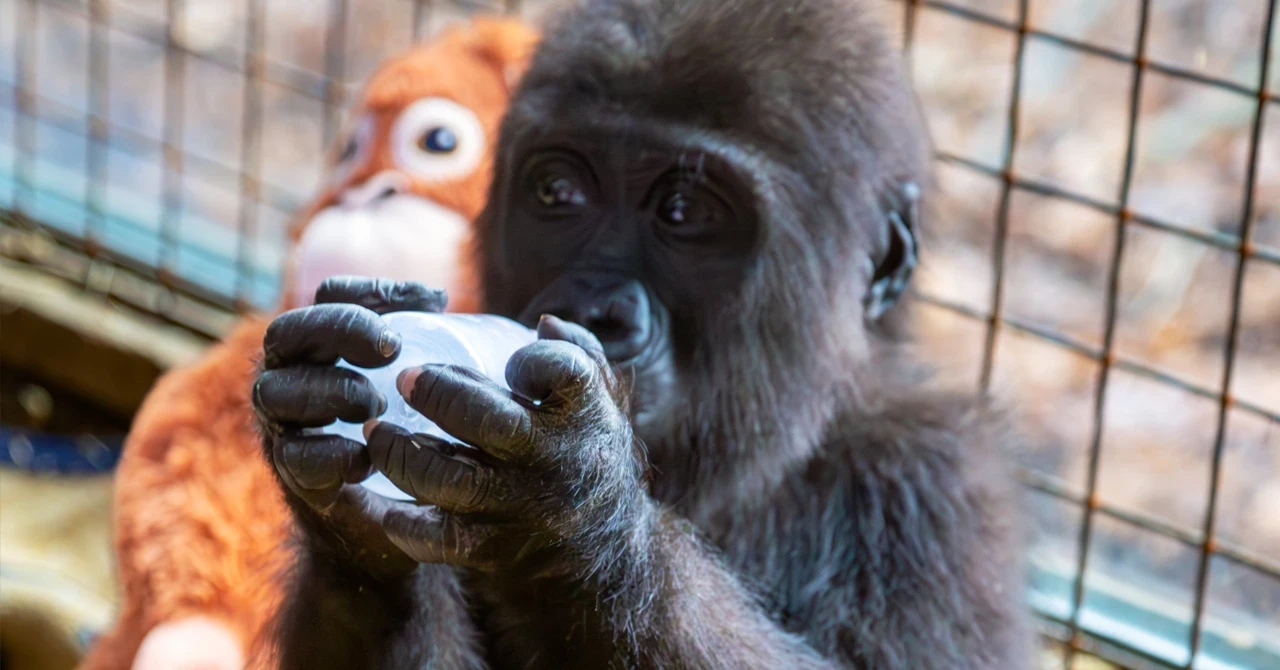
495;133;760;427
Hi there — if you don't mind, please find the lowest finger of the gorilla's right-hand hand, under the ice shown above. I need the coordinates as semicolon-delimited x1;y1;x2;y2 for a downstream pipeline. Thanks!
383;506;495;569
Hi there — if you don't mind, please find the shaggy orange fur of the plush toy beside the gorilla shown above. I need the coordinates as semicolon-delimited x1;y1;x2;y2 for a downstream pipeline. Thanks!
82;19;535;670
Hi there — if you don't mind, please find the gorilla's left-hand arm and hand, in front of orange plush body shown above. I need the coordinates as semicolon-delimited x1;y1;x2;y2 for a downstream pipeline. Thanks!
253;278;485;670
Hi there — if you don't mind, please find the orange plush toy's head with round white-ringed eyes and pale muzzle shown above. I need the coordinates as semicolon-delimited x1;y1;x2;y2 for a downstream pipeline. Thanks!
284;19;535;311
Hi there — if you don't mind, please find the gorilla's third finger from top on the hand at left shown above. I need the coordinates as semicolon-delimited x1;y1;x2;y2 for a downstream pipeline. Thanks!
253;368;387;428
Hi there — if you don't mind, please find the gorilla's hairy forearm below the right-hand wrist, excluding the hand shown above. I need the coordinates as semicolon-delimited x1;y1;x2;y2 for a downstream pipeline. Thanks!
489;498;837;669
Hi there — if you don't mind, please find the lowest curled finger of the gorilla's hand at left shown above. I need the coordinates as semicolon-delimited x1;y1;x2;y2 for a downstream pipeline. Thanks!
275;434;372;492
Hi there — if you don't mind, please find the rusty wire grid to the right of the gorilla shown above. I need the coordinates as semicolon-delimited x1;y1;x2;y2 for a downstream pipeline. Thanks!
899;0;1280;669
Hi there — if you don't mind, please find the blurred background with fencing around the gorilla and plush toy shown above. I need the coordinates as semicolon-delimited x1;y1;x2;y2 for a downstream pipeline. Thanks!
0;0;1280;669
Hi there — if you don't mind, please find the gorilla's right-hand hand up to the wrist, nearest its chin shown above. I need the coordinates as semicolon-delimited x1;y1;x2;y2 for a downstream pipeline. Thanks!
366;316;646;575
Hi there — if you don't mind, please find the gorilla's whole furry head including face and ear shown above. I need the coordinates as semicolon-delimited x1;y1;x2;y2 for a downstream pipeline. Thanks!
479;1;928;484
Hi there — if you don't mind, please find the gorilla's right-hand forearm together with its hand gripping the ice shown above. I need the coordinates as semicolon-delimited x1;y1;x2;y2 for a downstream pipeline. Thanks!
345;316;831;667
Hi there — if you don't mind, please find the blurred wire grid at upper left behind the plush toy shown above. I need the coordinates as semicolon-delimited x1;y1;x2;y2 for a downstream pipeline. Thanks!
0;0;521;336
